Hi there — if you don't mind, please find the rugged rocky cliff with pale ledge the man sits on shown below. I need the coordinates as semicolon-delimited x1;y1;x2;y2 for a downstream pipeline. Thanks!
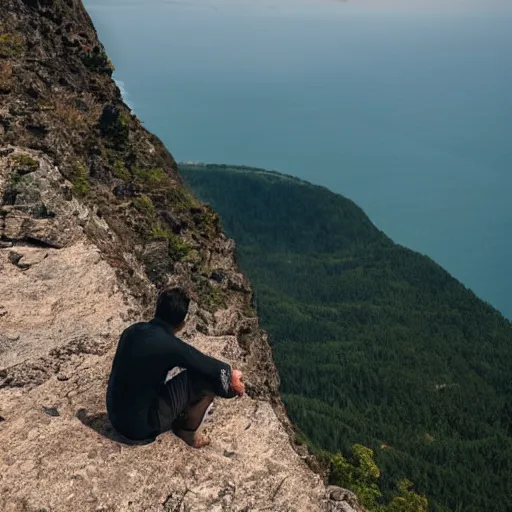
0;0;360;512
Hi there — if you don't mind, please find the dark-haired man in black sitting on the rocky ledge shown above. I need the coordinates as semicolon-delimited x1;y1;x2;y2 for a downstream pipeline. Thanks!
107;288;245;448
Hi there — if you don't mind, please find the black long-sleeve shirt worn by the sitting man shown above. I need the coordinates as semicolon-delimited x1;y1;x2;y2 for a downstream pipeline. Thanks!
107;318;236;439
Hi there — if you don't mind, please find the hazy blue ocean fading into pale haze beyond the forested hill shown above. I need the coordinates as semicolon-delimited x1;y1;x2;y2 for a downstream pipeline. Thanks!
85;0;512;318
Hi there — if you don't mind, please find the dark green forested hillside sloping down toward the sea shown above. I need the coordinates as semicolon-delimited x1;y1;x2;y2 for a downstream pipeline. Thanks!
181;165;512;512
